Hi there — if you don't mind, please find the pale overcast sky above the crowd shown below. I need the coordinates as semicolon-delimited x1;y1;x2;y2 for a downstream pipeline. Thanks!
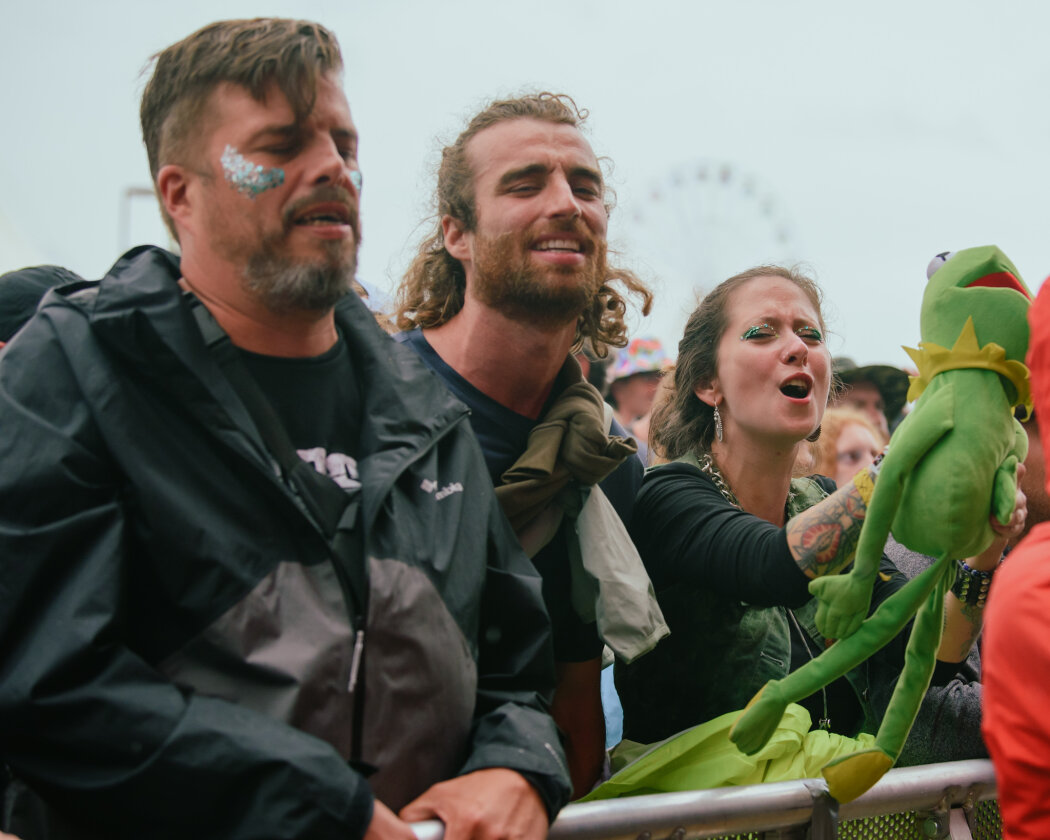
0;0;1050;364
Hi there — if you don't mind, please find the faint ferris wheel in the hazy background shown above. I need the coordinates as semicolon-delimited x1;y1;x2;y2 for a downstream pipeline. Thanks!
621;159;798;341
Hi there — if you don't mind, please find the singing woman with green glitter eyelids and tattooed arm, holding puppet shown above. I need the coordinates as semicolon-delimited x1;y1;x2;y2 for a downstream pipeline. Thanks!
616;266;1005;761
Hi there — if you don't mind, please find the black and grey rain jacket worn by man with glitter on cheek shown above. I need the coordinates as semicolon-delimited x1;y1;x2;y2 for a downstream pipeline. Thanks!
0;249;568;840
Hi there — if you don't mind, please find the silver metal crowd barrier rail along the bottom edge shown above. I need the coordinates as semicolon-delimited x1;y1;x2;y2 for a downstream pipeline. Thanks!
413;760;1002;840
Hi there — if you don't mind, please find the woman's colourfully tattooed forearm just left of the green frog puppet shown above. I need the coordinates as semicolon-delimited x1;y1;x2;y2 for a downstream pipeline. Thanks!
785;482;867;578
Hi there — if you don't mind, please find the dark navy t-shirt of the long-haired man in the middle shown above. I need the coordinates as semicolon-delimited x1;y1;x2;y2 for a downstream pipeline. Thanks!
395;330;643;663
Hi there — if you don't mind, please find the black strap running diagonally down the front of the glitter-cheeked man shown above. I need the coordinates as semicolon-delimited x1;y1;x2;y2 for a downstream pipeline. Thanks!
184;292;376;776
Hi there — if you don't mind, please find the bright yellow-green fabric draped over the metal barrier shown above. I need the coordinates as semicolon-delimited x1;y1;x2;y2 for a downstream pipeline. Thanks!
580;706;875;802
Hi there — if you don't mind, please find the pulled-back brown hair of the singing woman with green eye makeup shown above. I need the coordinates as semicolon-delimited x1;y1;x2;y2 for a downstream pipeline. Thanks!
649;266;824;461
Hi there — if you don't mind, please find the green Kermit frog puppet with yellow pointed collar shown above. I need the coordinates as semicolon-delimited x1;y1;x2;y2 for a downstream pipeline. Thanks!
730;246;1031;802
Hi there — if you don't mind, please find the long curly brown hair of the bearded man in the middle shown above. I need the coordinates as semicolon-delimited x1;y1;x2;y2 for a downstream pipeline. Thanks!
395;91;652;358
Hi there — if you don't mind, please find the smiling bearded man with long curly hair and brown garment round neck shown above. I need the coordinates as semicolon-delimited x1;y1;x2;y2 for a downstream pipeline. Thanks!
397;93;663;796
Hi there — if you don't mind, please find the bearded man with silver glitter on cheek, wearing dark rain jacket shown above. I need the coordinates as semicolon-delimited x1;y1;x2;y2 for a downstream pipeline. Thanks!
0;19;569;840
